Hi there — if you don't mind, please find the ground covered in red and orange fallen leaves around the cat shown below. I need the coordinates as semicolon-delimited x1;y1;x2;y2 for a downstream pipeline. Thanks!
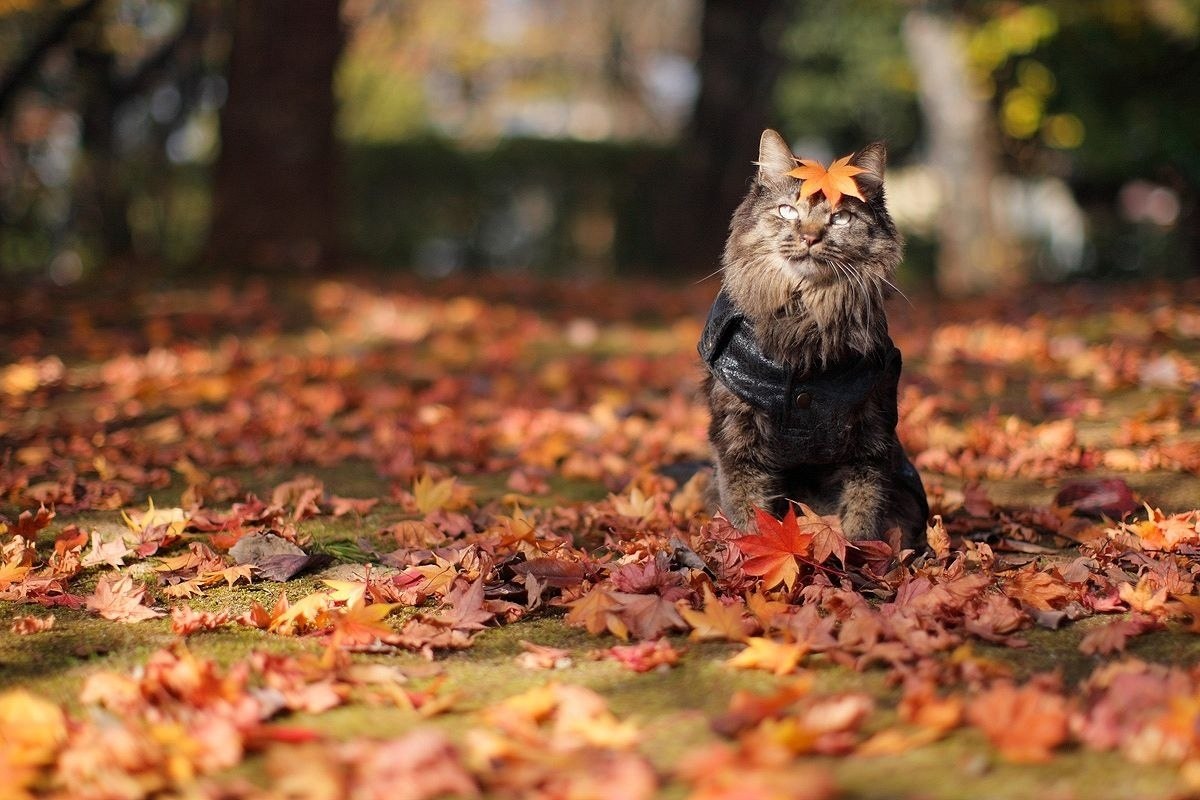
0;273;1200;800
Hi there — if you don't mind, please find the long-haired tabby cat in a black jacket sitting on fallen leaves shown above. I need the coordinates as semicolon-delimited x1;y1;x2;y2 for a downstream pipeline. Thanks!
698;130;929;547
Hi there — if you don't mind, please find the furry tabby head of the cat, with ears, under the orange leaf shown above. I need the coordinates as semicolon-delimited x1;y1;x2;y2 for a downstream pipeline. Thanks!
725;130;902;308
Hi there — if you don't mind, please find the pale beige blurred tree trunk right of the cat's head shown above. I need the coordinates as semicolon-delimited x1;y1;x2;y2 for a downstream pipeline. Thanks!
904;10;1024;295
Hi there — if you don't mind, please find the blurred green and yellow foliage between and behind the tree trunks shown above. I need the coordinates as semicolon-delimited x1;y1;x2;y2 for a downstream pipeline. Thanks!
0;0;1200;279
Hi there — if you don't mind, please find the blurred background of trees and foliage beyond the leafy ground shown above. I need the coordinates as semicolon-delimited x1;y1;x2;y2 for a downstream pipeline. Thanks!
0;0;1200;295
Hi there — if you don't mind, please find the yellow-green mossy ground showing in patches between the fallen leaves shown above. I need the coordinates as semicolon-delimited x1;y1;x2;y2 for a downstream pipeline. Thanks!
9;464;1200;800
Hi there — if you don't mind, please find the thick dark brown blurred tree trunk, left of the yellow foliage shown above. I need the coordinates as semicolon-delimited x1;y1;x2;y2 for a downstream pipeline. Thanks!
208;0;343;271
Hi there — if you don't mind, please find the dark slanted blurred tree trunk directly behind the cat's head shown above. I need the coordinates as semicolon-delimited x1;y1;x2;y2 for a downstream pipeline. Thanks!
662;0;792;271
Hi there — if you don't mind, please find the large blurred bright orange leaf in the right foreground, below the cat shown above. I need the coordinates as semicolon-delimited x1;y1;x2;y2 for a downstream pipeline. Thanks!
967;680;1067;763
